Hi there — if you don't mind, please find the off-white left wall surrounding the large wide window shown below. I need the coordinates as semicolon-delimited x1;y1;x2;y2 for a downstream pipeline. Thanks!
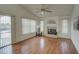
0;4;38;43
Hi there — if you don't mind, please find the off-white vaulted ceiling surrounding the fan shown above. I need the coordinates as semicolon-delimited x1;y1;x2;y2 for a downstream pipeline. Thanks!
22;4;74;18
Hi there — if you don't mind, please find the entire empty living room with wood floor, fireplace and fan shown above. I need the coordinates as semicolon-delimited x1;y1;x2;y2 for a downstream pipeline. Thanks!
0;4;79;54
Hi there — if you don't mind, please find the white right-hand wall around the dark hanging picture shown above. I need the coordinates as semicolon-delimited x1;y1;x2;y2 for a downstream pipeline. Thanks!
71;5;79;53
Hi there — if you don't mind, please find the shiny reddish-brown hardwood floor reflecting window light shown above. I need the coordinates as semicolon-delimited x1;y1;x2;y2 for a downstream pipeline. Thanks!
0;37;77;54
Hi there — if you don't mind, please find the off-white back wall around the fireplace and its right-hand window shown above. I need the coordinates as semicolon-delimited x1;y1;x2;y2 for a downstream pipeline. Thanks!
44;16;71;38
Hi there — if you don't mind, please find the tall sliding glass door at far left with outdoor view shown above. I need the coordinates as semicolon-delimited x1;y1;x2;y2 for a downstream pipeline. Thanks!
0;15;11;47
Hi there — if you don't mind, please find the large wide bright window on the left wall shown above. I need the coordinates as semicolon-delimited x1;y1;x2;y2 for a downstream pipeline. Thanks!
22;18;36;34
